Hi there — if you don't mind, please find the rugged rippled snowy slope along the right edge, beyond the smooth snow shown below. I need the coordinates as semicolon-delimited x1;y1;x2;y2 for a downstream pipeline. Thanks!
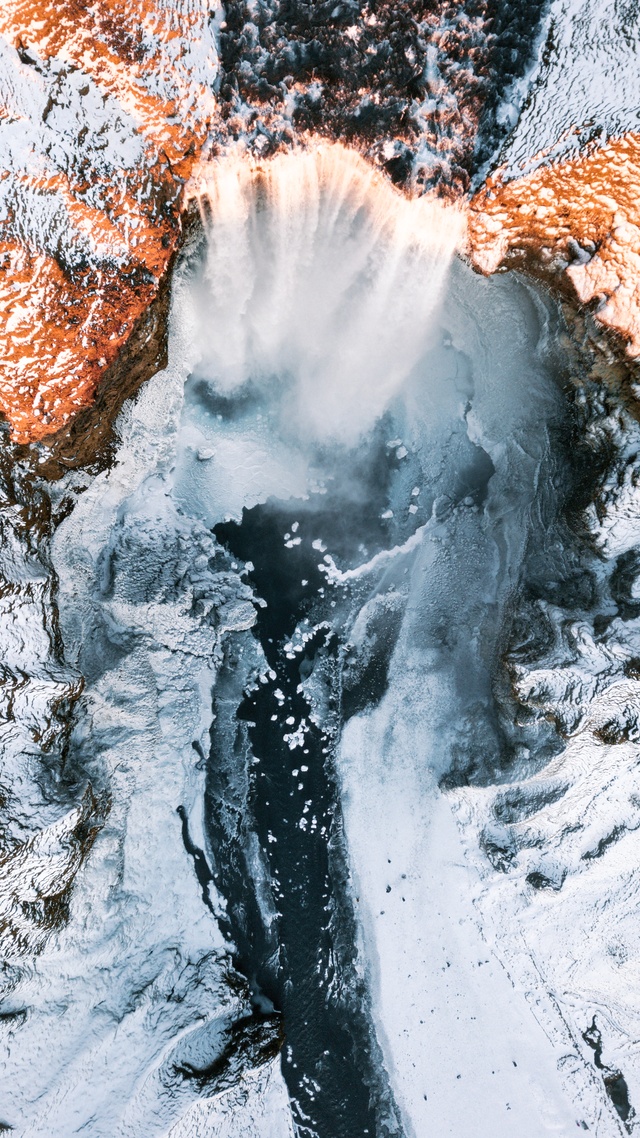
441;389;640;1132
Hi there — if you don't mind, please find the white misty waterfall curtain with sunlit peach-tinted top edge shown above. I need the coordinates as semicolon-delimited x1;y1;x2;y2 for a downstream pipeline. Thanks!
186;145;463;445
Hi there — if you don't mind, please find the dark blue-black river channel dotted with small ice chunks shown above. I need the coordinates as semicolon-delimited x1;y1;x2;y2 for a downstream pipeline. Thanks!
206;439;401;1138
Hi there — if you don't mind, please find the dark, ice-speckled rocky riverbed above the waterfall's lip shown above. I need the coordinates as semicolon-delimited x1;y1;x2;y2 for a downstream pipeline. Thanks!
212;0;543;197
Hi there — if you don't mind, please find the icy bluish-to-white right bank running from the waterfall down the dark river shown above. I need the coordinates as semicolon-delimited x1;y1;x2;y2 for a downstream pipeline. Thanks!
325;251;620;1138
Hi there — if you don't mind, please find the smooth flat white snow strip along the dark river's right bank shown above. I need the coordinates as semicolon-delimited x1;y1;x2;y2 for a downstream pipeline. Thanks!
340;714;592;1138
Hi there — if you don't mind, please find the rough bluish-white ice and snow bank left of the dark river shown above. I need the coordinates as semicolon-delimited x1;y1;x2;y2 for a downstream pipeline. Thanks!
1;264;289;1138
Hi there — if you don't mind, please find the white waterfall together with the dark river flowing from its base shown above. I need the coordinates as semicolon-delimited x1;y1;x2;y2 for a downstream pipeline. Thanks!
175;147;473;1138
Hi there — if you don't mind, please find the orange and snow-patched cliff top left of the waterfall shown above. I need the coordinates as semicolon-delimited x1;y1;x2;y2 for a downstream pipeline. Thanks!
0;0;216;442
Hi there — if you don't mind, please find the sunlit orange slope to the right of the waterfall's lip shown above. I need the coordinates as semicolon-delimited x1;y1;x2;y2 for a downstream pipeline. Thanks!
462;133;640;360
